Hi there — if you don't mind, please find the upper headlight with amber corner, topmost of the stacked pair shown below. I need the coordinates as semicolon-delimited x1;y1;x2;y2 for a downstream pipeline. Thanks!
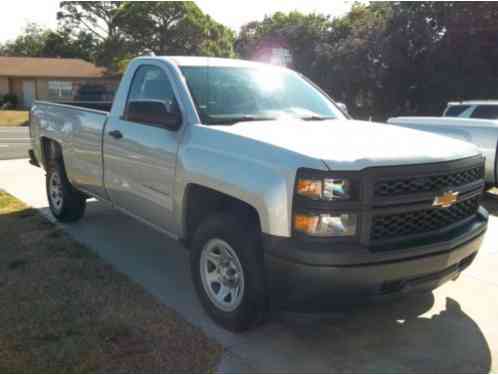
296;178;351;201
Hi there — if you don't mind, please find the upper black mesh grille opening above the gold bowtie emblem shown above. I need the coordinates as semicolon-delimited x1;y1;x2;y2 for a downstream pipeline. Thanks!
374;166;484;197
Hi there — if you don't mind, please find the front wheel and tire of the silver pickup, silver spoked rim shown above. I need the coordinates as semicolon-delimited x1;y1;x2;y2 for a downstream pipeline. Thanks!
190;214;266;332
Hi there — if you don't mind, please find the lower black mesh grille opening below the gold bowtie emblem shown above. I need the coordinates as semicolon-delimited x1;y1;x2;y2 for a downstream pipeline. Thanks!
370;197;479;241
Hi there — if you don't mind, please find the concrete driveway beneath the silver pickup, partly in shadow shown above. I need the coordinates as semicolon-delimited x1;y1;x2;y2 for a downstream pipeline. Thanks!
0;160;498;373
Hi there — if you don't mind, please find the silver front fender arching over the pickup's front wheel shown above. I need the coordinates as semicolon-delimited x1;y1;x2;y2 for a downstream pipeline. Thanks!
175;125;327;237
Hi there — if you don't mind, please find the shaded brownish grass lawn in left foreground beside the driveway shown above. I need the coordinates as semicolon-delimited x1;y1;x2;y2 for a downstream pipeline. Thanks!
0;191;222;373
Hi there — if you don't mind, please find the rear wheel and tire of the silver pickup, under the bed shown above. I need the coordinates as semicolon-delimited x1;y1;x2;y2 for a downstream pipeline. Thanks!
46;162;86;223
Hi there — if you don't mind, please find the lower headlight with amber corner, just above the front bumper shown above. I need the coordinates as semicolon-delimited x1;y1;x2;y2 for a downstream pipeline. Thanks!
294;213;358;237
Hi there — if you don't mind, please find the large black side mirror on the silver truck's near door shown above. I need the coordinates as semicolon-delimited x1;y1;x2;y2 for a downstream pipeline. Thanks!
125;100;182;131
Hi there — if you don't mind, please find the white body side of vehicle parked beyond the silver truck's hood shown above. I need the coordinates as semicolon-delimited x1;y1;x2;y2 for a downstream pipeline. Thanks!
387;116;498;189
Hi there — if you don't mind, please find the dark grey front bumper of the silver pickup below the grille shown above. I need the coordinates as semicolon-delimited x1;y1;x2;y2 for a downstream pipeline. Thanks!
264;208;488;311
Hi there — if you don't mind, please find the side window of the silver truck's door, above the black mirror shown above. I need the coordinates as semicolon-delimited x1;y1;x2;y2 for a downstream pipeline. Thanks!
125;65;180;122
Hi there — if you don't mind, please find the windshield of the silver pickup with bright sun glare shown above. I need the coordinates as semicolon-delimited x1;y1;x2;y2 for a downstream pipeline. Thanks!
181;66;344;125
